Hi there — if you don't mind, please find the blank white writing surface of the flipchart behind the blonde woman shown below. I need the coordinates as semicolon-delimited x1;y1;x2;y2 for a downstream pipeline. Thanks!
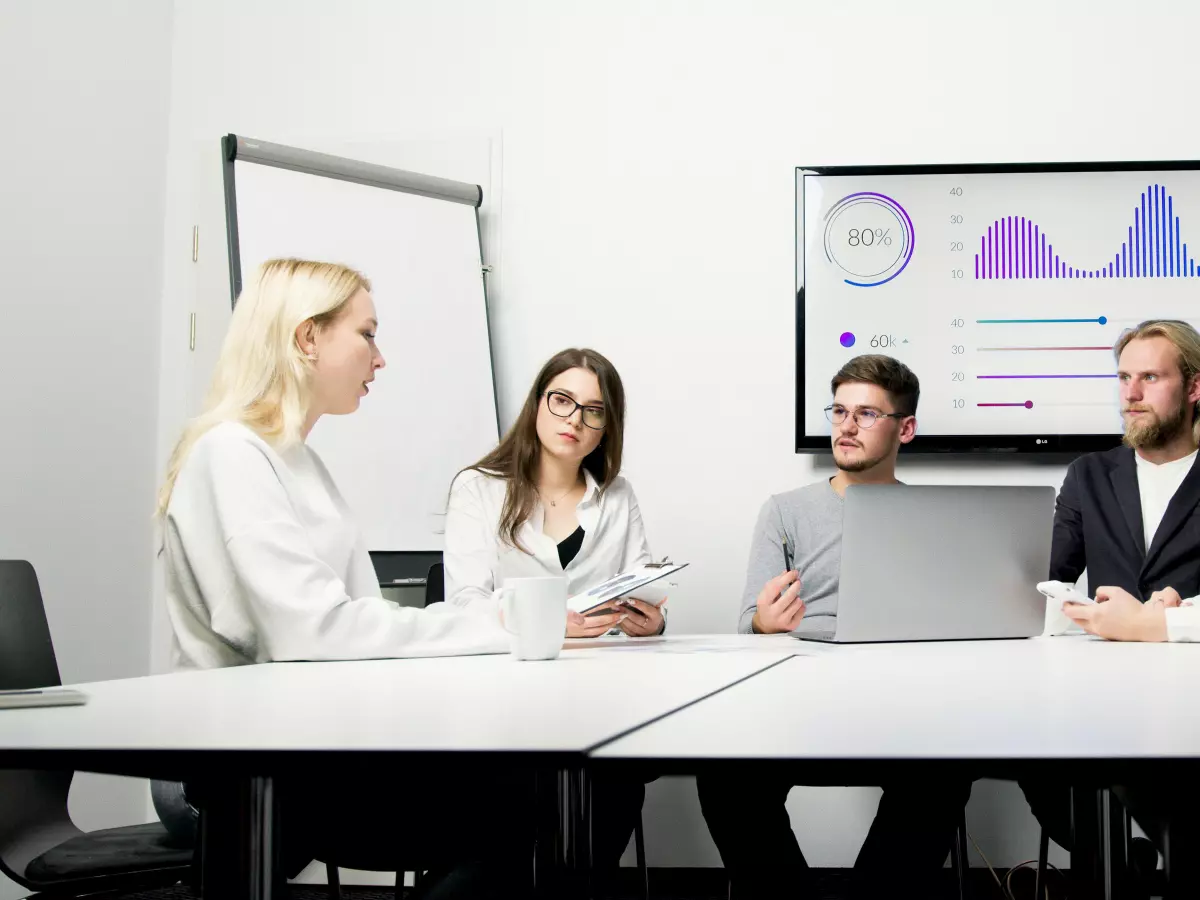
234;160;499;551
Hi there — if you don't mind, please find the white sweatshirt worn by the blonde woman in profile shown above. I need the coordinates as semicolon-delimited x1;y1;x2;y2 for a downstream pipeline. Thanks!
163;422;508;668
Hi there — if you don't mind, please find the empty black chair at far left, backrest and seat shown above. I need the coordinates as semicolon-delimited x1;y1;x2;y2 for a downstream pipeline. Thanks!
0;560;193;898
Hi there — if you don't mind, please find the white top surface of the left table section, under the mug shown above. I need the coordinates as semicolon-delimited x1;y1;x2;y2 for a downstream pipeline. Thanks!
0;636;803;755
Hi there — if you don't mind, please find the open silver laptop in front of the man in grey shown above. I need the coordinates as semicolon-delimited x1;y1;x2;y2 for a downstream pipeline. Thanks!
796;485;1055;643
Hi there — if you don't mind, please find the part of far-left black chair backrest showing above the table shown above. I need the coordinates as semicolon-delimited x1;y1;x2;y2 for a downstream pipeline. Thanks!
0;559;62;690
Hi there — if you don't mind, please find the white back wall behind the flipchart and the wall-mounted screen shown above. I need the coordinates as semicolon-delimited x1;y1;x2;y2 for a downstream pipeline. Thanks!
154;0;1200;878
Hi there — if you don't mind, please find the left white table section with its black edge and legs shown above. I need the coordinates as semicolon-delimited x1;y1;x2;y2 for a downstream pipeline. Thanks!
0;635;802;900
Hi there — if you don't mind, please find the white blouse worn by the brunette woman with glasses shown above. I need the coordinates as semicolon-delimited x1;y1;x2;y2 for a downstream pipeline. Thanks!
444;469;653;616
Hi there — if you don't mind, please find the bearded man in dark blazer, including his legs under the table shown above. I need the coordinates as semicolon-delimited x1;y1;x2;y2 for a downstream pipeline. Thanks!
1021;319;1200;896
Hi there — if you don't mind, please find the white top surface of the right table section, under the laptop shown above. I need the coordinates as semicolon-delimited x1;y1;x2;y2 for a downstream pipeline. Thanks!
593;637;1200;761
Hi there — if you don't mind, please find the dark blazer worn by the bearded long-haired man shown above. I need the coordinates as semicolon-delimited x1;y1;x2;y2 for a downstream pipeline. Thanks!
1050;446;1200;600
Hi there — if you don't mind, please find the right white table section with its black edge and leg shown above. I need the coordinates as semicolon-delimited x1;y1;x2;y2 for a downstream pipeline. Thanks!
590;636;1200;899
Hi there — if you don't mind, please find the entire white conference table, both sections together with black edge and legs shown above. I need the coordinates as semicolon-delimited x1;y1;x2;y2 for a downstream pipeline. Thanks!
0;636;1200;900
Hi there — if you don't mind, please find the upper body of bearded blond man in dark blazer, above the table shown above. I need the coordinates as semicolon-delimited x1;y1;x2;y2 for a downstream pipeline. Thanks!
1050;320;1200;641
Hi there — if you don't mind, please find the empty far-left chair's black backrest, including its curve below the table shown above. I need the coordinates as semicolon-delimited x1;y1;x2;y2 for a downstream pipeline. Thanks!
0;559;80;889
